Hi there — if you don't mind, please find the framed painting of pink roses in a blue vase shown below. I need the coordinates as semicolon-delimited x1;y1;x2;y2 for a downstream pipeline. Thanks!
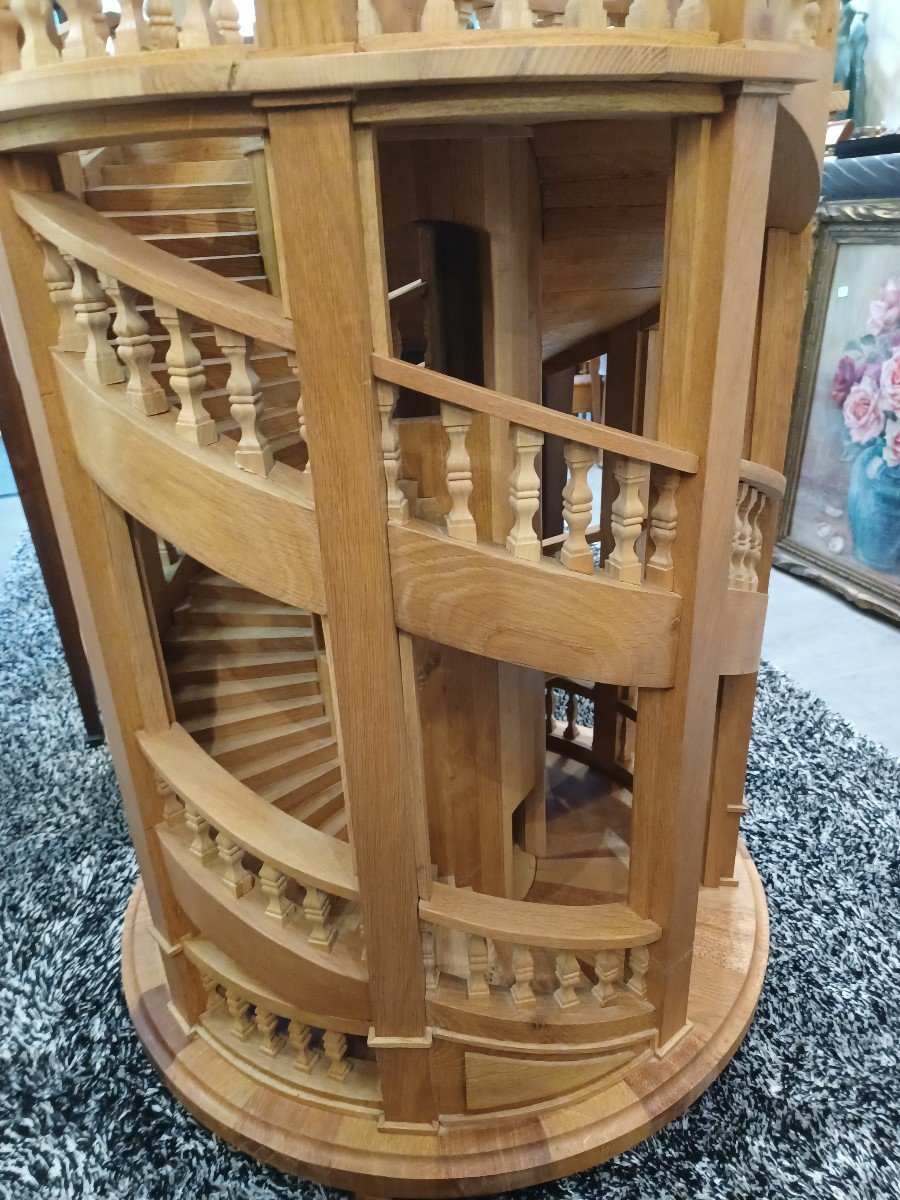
775;199;900;622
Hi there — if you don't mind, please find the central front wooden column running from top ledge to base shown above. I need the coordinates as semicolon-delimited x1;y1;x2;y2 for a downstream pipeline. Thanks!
270;104;434;1123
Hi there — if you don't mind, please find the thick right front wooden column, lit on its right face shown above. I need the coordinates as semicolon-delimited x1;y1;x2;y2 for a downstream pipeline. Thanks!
629;92;778;1044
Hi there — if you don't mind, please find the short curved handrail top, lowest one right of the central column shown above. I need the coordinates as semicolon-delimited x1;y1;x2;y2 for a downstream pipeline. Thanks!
419;883;661;953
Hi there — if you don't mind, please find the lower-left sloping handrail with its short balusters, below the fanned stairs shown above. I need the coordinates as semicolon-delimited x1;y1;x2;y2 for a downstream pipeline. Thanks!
138;725;359;952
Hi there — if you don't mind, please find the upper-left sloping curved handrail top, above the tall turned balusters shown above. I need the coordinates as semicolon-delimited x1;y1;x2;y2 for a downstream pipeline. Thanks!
10;184;294;350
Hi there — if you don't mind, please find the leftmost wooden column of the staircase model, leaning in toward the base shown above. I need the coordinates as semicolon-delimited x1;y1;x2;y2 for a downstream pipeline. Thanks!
0;157;205;1026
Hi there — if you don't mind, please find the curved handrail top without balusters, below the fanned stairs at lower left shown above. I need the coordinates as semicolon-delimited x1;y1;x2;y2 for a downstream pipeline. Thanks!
137;724;359;900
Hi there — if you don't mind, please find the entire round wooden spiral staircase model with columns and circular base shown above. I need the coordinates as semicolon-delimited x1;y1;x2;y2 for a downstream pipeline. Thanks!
0;0;835;1198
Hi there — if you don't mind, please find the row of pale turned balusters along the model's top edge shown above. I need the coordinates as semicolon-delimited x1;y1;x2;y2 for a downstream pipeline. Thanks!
0;0;820;73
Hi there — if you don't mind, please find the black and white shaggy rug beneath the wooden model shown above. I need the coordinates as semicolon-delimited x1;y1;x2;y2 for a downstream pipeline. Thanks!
0;542;900;1200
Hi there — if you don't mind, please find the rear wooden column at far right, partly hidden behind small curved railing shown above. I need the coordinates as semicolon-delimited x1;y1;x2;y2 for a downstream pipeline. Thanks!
703;229;811;887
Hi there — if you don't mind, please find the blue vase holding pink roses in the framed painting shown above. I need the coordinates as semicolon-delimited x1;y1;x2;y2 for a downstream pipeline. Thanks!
847;438;900;574
